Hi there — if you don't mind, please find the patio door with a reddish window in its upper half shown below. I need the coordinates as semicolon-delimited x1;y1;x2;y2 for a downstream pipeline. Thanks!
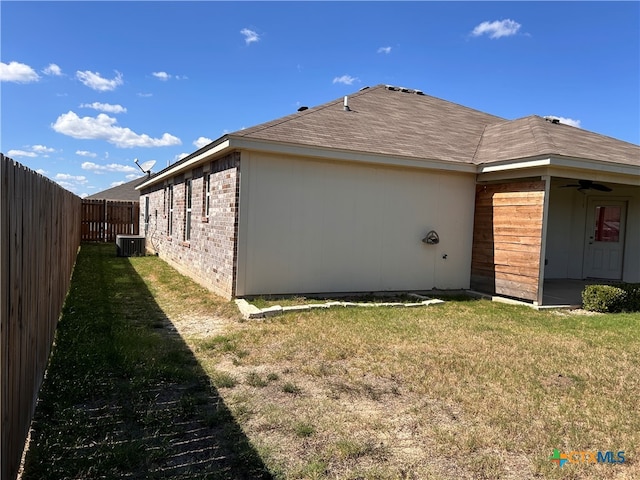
583;199;627;280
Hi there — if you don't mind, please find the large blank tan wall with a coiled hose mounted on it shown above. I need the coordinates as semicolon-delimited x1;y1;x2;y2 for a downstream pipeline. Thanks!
236;152;475;296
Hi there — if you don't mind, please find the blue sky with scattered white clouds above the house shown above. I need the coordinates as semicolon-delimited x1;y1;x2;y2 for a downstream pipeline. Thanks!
0;1;640;196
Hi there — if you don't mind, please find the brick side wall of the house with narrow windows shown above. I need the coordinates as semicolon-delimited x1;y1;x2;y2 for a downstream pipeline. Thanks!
140;152;240;298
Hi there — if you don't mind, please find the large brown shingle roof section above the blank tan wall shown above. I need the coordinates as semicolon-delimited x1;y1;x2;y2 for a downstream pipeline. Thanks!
229;85;504;163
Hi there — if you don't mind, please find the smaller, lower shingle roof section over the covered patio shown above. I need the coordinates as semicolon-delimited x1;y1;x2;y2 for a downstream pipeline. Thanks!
474;115;640;166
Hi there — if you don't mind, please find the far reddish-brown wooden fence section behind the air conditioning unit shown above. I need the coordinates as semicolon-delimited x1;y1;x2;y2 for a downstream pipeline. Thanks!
82;198;140;242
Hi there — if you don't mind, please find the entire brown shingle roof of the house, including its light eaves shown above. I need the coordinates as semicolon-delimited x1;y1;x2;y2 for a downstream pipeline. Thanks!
140;85;640;188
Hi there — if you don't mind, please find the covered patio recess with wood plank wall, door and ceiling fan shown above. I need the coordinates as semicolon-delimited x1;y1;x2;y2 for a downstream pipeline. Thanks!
471;172;640;308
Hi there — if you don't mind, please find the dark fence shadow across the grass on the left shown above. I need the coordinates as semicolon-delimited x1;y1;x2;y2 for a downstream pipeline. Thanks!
22;244;272;480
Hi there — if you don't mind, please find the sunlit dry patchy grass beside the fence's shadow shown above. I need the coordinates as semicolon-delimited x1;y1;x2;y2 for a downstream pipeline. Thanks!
35;248;640;480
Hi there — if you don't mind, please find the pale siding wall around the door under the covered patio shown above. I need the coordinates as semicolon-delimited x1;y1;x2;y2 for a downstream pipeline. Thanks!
545;179;640;282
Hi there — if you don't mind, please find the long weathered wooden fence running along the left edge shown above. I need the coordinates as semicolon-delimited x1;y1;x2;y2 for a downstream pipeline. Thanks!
0;154;81;480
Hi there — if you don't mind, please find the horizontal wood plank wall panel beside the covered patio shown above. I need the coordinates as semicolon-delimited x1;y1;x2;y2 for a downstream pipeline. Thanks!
471;181;545;301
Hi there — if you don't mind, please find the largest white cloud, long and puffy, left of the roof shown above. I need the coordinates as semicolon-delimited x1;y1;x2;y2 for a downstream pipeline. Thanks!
51;111;182;148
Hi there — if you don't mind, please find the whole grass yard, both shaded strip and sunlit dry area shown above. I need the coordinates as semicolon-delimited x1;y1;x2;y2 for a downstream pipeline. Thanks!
25;246;640;480
